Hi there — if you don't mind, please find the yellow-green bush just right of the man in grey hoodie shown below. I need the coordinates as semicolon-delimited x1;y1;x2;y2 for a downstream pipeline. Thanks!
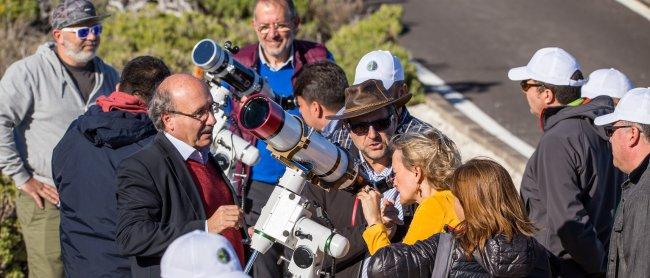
99;4;255;72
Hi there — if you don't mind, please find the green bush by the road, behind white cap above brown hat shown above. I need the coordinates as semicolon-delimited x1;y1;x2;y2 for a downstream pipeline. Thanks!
327;5;424;104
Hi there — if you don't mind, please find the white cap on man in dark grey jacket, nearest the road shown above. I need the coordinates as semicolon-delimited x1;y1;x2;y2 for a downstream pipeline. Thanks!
508;47;585;87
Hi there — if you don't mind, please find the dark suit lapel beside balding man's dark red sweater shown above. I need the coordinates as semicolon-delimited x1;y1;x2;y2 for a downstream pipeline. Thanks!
155;132;207;219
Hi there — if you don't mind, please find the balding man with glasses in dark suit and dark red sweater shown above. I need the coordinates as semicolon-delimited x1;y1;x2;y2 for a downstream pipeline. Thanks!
117;74;245;277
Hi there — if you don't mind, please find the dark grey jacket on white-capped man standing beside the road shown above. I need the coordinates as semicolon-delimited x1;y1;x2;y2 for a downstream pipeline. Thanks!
521;96;624;277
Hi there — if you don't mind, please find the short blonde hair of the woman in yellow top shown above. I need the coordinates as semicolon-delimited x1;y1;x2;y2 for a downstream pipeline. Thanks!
391;129;461;190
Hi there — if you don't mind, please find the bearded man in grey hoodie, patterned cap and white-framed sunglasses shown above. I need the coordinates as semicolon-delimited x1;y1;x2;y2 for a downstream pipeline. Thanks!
0;0;119;277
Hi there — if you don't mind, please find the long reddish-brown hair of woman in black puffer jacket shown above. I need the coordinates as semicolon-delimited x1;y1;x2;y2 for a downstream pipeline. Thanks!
450;158;535;256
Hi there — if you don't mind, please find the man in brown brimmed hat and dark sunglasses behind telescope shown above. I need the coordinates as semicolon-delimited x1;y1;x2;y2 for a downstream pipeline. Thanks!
304;79;418;277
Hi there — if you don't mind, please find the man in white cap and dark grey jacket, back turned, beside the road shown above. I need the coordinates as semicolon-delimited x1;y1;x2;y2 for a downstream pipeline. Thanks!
508;47;623;277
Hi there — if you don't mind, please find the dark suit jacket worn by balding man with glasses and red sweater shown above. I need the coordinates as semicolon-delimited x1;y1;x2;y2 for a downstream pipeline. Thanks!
117;132;237;277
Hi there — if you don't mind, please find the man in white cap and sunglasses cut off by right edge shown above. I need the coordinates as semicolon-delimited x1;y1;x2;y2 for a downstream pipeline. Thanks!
594;88;650;277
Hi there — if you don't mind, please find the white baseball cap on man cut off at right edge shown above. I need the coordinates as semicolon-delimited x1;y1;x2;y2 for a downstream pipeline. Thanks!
594;87;650;125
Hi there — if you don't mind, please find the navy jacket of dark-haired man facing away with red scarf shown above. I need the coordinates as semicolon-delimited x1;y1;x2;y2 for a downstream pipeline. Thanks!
52;106;156;277
